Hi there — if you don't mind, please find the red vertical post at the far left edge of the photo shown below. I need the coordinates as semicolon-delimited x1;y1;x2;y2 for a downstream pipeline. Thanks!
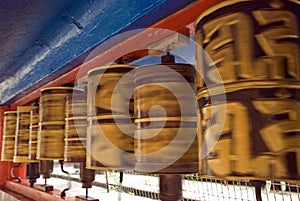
0;106;11;186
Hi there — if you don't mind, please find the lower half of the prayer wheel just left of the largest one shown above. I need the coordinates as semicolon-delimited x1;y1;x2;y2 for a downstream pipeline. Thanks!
134;117;198;174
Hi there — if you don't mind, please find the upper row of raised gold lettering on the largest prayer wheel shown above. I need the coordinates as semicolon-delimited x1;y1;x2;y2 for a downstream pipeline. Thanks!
195;9;300;88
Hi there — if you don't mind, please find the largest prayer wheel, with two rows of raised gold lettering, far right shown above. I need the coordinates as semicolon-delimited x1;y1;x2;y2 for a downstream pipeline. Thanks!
195;0;300;183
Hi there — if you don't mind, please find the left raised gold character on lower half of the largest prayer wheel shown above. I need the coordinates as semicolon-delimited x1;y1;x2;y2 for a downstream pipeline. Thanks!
203;102;251;176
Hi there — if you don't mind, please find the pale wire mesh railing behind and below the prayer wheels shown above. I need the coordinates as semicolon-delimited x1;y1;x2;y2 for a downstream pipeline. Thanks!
53;165;300;201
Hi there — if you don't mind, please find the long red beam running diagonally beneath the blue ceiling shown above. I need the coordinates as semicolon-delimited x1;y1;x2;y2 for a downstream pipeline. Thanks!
12;0;224;108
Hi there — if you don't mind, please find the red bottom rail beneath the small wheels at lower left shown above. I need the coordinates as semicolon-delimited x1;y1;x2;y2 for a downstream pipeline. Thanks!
5;181;75;201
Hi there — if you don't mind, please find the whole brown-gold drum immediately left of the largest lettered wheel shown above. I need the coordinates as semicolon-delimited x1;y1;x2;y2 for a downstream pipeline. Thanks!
134;63;198;174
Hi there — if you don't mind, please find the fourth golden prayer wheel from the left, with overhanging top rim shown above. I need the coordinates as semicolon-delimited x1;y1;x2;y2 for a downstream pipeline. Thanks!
37;87;81;160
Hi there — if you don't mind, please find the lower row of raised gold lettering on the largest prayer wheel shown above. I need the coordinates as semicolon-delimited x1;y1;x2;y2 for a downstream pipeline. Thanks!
201;90;300;179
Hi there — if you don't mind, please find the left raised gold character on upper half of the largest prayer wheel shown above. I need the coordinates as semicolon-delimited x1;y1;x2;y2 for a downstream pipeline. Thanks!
200;13;253;83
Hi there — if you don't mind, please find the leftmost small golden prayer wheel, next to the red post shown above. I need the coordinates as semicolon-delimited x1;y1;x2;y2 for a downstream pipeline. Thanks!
1;111;17;161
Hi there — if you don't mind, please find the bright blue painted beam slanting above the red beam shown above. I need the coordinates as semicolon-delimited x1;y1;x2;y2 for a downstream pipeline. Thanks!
0;0;195;104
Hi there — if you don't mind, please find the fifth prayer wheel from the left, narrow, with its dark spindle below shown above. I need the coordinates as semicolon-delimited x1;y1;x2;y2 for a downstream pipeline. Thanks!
64;90;98;200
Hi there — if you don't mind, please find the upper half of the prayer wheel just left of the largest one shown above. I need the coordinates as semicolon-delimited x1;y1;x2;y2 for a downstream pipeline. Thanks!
134;63;196;118
